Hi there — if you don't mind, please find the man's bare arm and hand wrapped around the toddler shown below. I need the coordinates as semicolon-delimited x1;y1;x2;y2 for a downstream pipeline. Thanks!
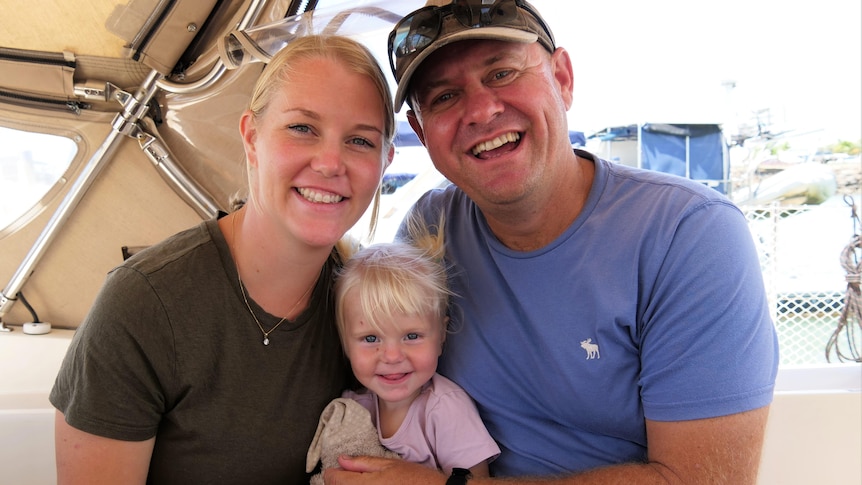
325;406;769;485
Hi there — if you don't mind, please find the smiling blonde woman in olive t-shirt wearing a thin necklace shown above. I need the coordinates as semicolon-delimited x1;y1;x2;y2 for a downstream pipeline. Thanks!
51;36;394;485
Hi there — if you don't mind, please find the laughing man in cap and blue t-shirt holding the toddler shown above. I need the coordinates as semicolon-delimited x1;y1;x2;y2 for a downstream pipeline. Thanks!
327;0;778;485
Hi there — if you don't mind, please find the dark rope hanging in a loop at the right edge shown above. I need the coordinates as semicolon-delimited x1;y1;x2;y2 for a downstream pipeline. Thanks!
826;197;862;362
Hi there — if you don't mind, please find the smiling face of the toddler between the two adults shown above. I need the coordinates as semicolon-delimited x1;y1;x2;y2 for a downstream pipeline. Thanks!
344;291;444;406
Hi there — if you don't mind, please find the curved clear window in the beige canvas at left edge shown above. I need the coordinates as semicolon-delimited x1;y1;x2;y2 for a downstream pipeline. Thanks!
0;127;78;231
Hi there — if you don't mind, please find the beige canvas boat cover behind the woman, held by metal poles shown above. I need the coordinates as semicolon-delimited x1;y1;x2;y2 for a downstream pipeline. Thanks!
0;0;290;328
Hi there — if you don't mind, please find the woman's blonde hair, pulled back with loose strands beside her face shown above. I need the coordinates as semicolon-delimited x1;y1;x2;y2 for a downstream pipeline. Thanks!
240;35;395;238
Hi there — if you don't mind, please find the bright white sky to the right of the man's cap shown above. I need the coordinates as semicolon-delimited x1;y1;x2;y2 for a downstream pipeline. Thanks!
531;0;862;143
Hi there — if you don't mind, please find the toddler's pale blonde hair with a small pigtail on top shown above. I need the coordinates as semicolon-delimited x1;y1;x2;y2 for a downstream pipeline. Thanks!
335;218;454;348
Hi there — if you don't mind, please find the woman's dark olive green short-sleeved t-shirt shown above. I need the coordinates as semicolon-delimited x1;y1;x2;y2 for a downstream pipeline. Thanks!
50;219;350;485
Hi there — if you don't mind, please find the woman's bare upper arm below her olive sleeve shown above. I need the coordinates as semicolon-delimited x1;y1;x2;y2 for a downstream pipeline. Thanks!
54;411;156;485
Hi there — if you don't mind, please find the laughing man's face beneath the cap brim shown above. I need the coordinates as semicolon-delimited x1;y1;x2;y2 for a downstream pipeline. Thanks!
408;40;572;211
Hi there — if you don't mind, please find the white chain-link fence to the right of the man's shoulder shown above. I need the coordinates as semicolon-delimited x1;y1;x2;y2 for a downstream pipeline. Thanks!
742;200;858;365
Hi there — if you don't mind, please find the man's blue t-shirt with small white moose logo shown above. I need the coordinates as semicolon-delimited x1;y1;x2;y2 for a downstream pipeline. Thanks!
404;151;778;476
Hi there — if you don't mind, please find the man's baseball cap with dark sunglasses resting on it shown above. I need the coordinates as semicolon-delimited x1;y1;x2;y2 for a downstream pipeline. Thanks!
389;0;556;112
